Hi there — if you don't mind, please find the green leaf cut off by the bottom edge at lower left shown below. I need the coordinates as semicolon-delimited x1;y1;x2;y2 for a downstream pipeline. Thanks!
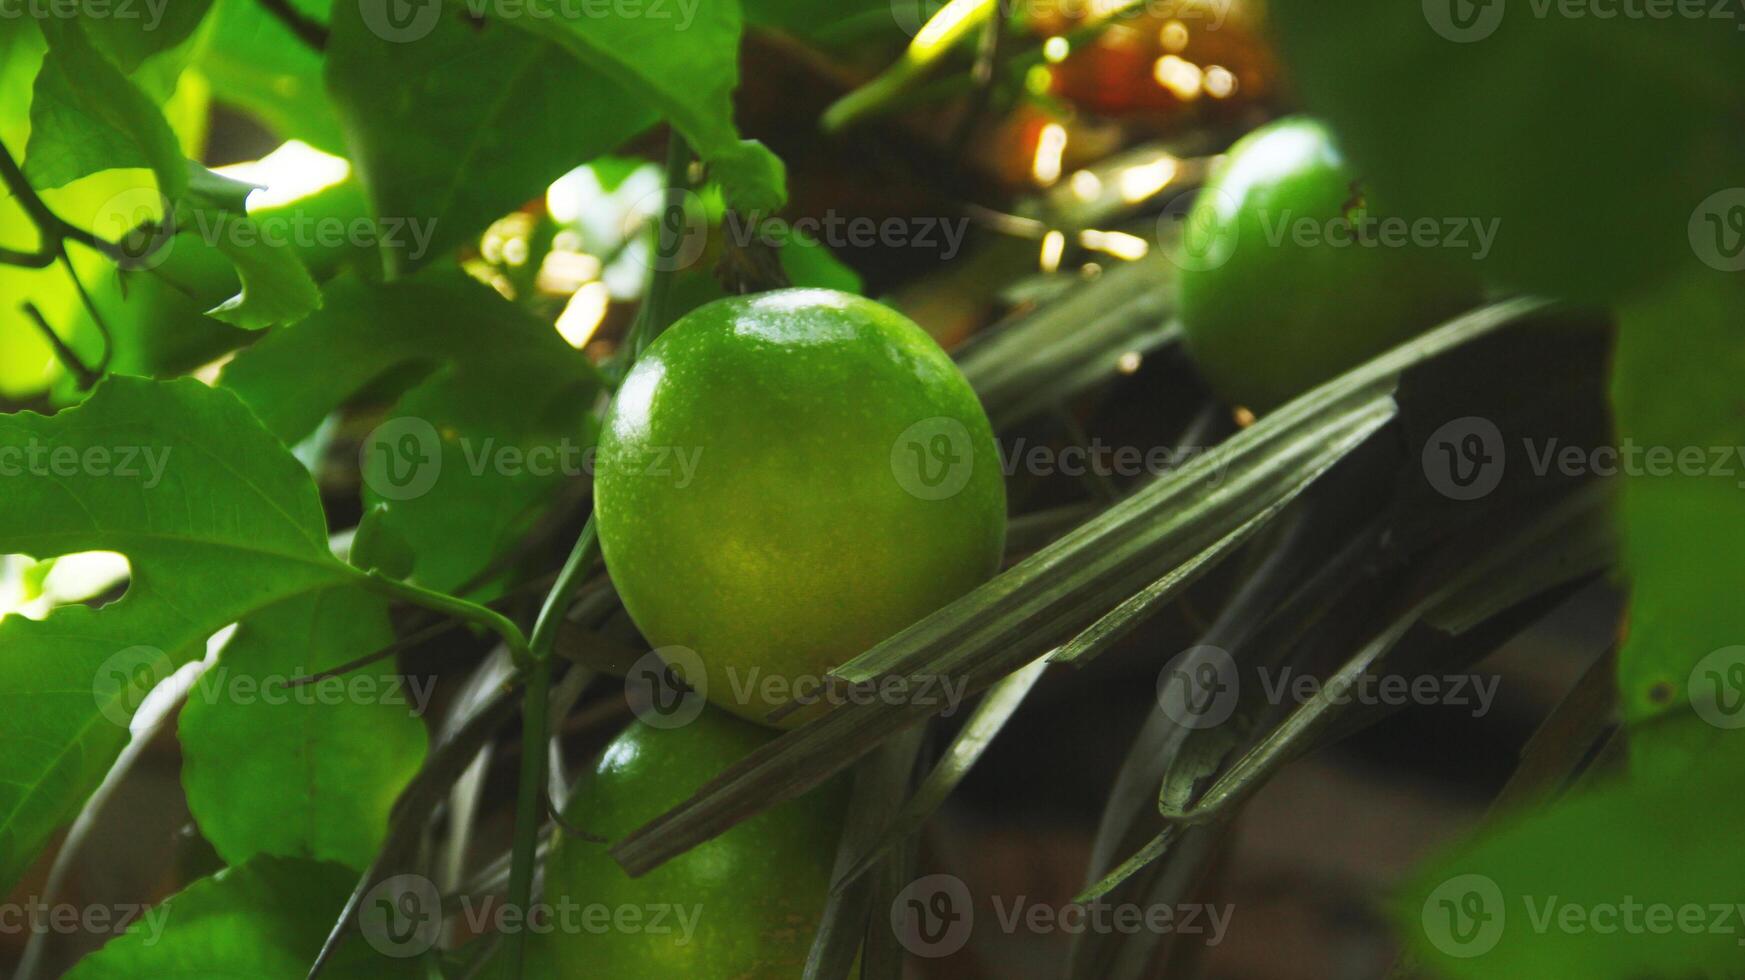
66;858;421;980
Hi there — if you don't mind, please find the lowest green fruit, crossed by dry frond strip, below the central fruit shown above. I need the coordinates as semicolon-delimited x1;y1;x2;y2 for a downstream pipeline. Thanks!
544;708;848;980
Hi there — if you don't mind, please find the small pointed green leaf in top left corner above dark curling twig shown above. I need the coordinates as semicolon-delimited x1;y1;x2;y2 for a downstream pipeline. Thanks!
24;17;188;201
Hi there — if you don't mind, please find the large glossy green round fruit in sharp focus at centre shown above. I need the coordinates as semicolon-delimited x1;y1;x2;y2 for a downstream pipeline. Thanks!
595;289;1005;725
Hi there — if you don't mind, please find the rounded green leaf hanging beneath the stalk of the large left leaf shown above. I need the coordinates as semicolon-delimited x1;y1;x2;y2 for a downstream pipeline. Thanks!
180;588;426;870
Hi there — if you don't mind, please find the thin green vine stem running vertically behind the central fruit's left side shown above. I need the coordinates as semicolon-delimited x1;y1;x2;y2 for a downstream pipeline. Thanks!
504;131;691;980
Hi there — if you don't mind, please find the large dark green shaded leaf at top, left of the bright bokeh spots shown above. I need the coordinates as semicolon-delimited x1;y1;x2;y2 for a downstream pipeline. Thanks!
326;3;654;272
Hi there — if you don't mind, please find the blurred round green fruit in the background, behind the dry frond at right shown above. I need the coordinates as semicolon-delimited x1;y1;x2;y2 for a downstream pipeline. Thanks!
1178;117;1480;412
